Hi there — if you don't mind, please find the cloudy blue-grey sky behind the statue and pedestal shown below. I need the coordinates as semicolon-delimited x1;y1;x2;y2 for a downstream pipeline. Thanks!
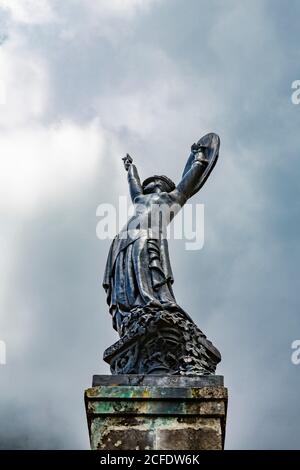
0;0;300;449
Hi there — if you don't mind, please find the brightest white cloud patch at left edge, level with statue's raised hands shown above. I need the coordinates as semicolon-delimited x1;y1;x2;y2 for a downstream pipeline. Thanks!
0;120;104;213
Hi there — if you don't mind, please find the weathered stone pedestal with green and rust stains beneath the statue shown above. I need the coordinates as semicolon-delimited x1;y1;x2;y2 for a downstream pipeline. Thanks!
85;374;227;450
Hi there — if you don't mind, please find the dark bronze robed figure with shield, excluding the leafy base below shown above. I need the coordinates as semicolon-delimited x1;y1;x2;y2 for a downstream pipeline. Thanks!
103;133;220;336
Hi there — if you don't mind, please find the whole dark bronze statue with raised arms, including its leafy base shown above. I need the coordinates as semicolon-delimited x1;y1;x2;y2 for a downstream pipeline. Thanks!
103;133;221;375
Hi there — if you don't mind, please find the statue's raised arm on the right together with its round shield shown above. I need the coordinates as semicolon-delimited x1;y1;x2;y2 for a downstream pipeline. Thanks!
173;133;220;205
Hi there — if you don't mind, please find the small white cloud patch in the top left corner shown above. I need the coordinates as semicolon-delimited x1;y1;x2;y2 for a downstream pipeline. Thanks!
0;0;55;24
